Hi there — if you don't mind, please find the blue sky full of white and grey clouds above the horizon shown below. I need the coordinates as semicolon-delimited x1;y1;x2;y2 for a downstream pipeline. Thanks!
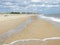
0;0;60;14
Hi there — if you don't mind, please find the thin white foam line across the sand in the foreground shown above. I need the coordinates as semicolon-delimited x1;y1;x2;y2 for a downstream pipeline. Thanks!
3;37;60;45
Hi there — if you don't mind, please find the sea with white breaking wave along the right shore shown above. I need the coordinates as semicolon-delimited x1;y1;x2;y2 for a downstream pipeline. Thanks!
38;14;60;27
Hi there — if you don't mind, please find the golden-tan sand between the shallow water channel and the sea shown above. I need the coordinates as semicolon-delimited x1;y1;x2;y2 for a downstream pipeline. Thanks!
4;15;60;43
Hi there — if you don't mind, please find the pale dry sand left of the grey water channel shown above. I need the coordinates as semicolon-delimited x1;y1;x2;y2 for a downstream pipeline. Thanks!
0;14;29;34
